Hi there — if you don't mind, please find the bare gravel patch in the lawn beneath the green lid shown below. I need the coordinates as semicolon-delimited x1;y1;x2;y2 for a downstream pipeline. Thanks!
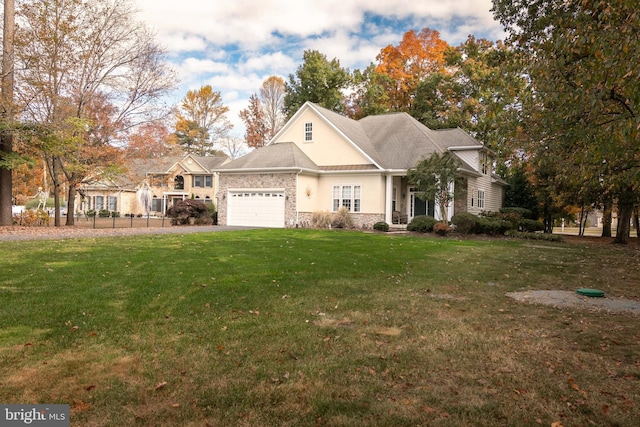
505;290;640;316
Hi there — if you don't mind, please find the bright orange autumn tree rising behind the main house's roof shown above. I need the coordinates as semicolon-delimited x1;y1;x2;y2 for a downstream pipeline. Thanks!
375;28;449;112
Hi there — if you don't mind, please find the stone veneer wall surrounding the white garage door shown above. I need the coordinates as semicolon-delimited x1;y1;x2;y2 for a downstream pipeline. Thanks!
217;173;296;227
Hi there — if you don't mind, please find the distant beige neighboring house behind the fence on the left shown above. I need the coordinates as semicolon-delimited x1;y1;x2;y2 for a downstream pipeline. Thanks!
76;154;230;216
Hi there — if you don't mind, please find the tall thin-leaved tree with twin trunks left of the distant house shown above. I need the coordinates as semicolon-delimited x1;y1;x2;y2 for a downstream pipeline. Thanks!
16;0;176;226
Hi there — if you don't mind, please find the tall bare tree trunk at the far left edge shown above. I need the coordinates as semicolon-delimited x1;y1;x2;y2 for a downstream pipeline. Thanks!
0;0;15;226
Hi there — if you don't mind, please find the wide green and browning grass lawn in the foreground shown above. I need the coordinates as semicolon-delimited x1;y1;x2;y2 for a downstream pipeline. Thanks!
0;230;640;426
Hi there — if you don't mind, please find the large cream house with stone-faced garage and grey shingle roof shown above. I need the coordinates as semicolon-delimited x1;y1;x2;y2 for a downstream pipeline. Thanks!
217;102;506;228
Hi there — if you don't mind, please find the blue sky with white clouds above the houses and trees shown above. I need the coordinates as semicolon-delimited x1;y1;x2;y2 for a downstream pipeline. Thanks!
137;0;504;137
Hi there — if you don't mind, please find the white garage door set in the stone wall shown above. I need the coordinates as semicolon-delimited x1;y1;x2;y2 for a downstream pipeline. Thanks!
227;190;285;228
